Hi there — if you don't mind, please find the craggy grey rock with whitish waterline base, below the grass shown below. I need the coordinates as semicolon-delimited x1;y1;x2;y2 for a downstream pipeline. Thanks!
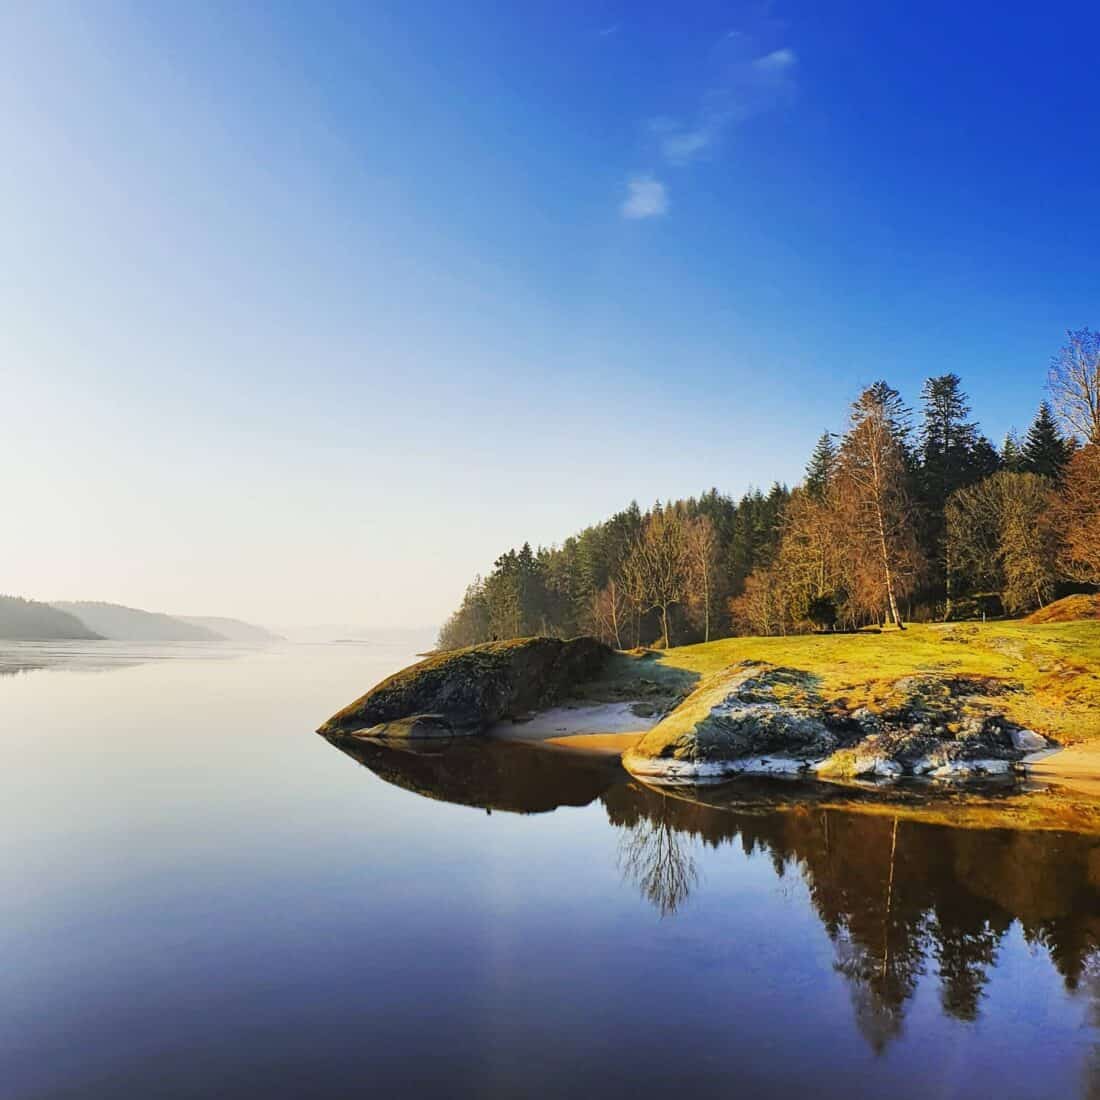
623;664;1048;782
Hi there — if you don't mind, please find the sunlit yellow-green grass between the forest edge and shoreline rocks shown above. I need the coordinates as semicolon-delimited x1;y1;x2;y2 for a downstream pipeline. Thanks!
615;620;1100;745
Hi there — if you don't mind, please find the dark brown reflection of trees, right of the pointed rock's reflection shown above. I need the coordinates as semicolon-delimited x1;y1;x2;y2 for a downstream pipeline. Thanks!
602;785;1100;1047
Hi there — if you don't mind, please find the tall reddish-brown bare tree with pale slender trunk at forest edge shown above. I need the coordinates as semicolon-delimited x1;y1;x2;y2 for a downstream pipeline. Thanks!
837;382;920;630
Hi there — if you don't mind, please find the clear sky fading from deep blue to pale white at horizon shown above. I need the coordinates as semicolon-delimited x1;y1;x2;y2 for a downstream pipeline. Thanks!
0;0;1100;626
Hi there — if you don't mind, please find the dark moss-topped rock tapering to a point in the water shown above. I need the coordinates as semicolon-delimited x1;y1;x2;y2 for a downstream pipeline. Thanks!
318;638;611;738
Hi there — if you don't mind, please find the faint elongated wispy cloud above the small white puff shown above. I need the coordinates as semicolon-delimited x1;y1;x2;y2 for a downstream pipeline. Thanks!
649;31;799;166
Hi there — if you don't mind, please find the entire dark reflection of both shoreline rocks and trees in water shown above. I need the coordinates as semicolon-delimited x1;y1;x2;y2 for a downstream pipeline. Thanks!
330;741;1100;1052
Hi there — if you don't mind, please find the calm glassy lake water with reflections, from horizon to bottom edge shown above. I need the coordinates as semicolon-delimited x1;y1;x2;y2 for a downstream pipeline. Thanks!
0;644;1100;1100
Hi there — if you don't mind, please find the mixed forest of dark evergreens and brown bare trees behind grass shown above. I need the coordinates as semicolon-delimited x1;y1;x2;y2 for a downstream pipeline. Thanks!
439;329;1100;649
